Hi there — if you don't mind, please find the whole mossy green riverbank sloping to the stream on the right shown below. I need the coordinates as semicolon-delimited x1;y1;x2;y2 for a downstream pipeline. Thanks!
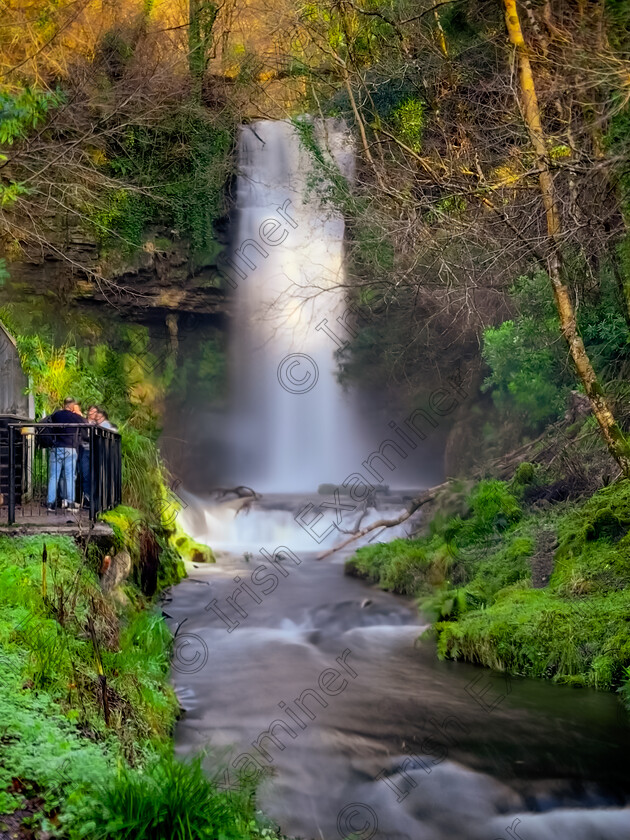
346;464;630;708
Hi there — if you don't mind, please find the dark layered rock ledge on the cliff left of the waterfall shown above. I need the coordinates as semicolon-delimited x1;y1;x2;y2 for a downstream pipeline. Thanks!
8;213;226;323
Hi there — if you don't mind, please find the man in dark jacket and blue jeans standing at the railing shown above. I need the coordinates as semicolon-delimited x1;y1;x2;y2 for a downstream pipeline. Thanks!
48;397;87;511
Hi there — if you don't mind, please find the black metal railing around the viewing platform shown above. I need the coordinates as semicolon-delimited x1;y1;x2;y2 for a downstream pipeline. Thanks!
0;424;122;525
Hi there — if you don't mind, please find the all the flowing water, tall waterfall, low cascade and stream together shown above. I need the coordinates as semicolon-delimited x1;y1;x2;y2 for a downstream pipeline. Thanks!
165;121;630;840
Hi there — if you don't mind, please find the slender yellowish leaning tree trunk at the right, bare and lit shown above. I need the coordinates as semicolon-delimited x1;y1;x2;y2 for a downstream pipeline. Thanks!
503;0;630;477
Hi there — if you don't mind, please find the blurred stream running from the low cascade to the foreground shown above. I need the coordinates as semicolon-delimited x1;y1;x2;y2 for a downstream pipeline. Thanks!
165;502;630;840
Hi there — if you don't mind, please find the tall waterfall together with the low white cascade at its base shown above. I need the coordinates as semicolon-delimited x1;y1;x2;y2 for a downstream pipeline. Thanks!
182;118;439;550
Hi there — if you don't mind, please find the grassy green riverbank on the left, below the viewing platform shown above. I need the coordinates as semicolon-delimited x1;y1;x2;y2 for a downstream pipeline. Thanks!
0;535;278;840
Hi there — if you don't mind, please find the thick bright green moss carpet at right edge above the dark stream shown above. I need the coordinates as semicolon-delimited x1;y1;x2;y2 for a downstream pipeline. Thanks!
436;481;630;698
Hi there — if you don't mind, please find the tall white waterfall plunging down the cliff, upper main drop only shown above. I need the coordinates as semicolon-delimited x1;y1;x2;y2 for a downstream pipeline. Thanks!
224;119;365;492
